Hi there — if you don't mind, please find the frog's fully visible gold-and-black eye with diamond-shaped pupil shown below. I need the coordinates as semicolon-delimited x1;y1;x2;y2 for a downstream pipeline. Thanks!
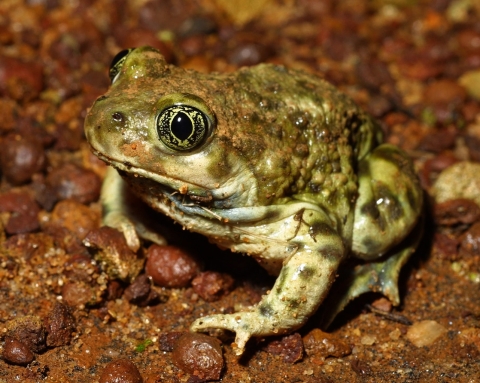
156;104;212;151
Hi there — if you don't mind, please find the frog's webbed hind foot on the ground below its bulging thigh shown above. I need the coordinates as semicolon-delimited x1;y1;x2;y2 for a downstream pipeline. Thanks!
321;219;423;327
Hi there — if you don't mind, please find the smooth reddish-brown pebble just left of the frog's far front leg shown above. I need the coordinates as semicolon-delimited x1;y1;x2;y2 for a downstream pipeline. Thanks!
47;164;102;204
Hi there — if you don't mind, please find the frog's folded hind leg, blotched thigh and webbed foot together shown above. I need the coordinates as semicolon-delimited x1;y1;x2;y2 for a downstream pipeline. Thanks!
322;144;423;325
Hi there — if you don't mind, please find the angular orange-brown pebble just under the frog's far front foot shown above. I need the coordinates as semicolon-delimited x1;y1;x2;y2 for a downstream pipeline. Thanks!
83;226;143;282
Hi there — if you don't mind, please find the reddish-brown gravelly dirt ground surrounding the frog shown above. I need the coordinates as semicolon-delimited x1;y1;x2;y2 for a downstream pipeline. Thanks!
0;0;480;383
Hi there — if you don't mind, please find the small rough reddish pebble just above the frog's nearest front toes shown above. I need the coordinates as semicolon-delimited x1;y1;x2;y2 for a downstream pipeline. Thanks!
192;271;234;302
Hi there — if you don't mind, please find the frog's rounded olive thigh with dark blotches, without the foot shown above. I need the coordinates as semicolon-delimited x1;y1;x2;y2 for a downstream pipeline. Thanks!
352;144;422;260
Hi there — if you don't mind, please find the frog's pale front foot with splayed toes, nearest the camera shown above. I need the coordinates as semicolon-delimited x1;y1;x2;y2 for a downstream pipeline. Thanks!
190;312;283;355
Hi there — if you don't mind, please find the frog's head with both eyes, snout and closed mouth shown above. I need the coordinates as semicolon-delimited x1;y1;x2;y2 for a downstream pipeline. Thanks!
85;47;257;224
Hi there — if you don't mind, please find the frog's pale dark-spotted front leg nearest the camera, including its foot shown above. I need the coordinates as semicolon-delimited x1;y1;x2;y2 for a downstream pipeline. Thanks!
191;222;345;355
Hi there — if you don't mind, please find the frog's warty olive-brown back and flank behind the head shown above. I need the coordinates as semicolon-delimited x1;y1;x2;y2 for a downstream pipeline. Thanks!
219;64;382;214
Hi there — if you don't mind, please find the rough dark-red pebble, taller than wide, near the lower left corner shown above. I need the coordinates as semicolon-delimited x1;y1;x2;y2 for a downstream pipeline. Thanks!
44;302;75;347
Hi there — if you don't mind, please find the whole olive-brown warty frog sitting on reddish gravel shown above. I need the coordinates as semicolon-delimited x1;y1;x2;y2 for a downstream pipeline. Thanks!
85;46;423;355
